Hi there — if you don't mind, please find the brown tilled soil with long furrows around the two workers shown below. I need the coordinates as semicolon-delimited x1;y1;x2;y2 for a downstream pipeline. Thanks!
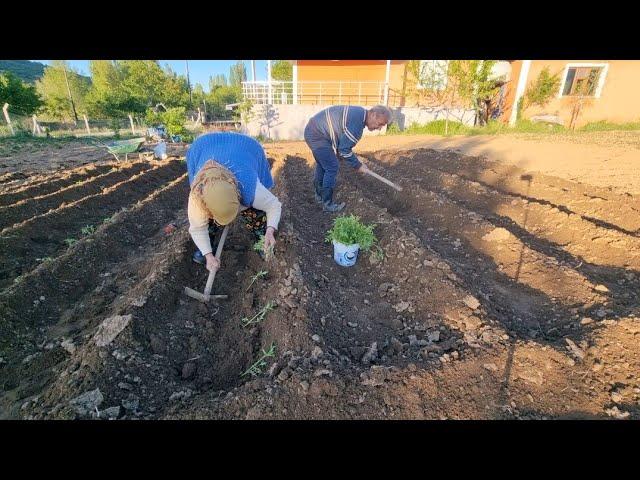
0;142;640;419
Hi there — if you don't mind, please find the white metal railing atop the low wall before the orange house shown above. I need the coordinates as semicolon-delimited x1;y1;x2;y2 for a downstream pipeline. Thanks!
242;80;401;106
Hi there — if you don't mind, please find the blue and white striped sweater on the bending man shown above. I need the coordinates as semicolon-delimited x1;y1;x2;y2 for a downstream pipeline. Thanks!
310;105;367;168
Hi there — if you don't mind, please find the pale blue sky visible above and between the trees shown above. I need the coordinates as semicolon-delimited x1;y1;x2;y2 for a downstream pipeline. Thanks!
34;60;267;92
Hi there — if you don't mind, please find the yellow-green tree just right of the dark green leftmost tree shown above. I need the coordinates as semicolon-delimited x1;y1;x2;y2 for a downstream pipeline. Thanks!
36;60;91;120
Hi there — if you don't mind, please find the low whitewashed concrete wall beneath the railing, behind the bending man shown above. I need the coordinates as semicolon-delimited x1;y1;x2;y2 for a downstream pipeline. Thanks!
241;105;475;140
